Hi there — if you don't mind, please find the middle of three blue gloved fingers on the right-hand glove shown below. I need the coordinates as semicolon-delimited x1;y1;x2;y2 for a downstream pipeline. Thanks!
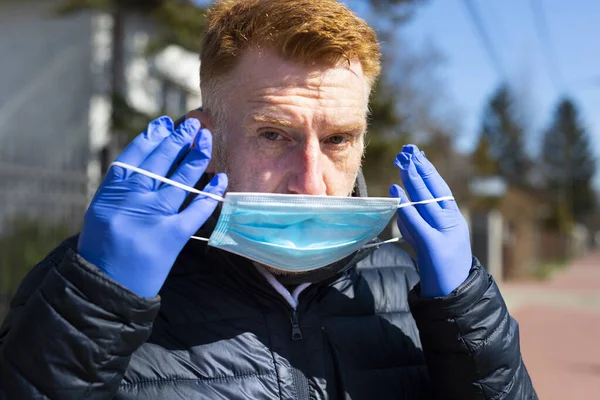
395;152;442;226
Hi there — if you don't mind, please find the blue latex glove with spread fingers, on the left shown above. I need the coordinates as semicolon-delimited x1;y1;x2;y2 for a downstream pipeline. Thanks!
78;117;227;297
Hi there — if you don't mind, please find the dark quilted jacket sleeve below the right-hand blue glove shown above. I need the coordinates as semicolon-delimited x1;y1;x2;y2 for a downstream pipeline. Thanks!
409;259;537;400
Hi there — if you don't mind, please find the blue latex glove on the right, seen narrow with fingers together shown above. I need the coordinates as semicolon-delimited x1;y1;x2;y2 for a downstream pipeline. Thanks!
390;145;473;297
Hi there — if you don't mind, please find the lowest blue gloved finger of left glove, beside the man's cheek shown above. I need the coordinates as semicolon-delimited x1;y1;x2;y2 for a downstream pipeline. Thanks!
179;174;228;236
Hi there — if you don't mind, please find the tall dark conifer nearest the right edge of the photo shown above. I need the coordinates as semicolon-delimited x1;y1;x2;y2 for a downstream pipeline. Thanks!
541;99;596;225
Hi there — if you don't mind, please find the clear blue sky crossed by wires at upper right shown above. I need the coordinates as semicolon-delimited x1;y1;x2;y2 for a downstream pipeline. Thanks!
396;0;600;189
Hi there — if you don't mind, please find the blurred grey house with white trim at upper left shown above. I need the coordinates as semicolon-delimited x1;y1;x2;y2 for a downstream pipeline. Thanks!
0;0;201;233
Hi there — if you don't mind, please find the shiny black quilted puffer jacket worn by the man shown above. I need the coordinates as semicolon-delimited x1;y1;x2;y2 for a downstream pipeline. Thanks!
0;231;537;400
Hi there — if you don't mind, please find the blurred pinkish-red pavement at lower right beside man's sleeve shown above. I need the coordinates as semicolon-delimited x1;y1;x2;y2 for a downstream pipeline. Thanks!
500;252;600;400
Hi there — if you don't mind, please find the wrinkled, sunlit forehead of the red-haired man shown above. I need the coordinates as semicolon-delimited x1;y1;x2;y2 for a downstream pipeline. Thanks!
227;48;369;131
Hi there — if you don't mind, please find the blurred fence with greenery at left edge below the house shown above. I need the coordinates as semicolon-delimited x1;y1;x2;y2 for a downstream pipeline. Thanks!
0;164;88;317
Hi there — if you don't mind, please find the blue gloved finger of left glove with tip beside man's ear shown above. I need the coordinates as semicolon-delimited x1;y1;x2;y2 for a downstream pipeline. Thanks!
160;129;212;210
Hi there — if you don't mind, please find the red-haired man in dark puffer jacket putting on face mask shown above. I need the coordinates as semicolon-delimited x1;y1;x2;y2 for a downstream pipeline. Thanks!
0;0;537;400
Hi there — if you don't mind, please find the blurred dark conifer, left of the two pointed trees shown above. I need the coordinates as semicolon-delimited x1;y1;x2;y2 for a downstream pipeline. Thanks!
473;84;531;186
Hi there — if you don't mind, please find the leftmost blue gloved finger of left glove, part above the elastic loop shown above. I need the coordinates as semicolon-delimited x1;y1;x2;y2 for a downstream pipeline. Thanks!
116;117;173;167
